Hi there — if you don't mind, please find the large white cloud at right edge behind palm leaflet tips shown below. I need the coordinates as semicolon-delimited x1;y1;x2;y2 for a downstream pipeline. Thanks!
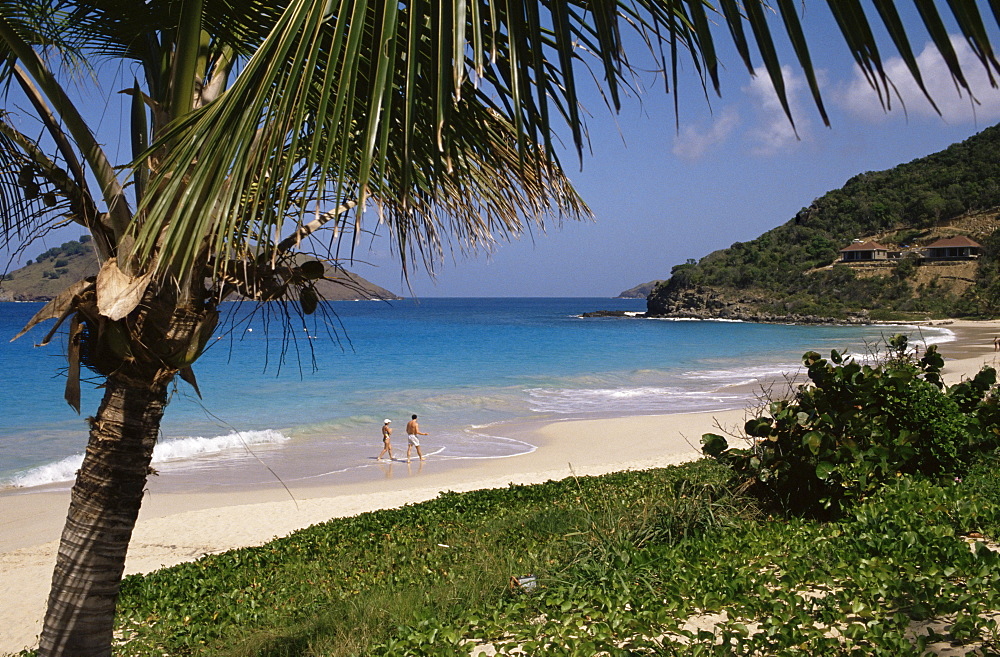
838;35;1000;125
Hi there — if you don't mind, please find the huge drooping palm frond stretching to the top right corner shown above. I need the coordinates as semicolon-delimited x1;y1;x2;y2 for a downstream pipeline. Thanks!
125;0;996;282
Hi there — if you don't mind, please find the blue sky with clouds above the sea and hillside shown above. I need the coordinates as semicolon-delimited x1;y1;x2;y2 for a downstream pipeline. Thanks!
0;3;1000;297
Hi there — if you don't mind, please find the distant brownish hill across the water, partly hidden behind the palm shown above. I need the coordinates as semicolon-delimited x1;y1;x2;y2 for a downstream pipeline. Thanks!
0;235;400;301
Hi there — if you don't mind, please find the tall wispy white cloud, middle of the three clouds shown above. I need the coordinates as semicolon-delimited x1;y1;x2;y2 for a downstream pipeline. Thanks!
743;65;811;155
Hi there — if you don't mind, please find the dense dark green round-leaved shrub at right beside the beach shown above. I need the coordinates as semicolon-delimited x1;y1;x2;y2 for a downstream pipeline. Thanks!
702;335;1000;515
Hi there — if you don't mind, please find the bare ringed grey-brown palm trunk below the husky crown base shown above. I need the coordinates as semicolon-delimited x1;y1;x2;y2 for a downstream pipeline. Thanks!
38;371;172;657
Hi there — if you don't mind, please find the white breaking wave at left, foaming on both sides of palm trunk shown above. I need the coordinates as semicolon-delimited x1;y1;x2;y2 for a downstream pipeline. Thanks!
0;429;288;488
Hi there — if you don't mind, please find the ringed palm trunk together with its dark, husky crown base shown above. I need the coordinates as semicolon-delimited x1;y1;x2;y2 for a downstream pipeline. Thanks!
39;286;217;655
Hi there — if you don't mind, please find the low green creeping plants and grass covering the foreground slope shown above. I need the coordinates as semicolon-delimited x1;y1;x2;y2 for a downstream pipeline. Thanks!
95;456;1000;657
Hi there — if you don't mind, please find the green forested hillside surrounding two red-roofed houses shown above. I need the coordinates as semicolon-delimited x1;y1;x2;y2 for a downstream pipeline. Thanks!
647;126;1000;321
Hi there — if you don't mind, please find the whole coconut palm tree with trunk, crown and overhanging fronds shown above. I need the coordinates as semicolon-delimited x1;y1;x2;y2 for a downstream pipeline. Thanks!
0;0;1000;655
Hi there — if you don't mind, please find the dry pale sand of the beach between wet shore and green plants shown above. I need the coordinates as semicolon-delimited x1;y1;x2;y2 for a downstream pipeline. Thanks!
0;320;1000;654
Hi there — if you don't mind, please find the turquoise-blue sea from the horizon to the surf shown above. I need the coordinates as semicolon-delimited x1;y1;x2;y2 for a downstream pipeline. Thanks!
0;298;953;492
